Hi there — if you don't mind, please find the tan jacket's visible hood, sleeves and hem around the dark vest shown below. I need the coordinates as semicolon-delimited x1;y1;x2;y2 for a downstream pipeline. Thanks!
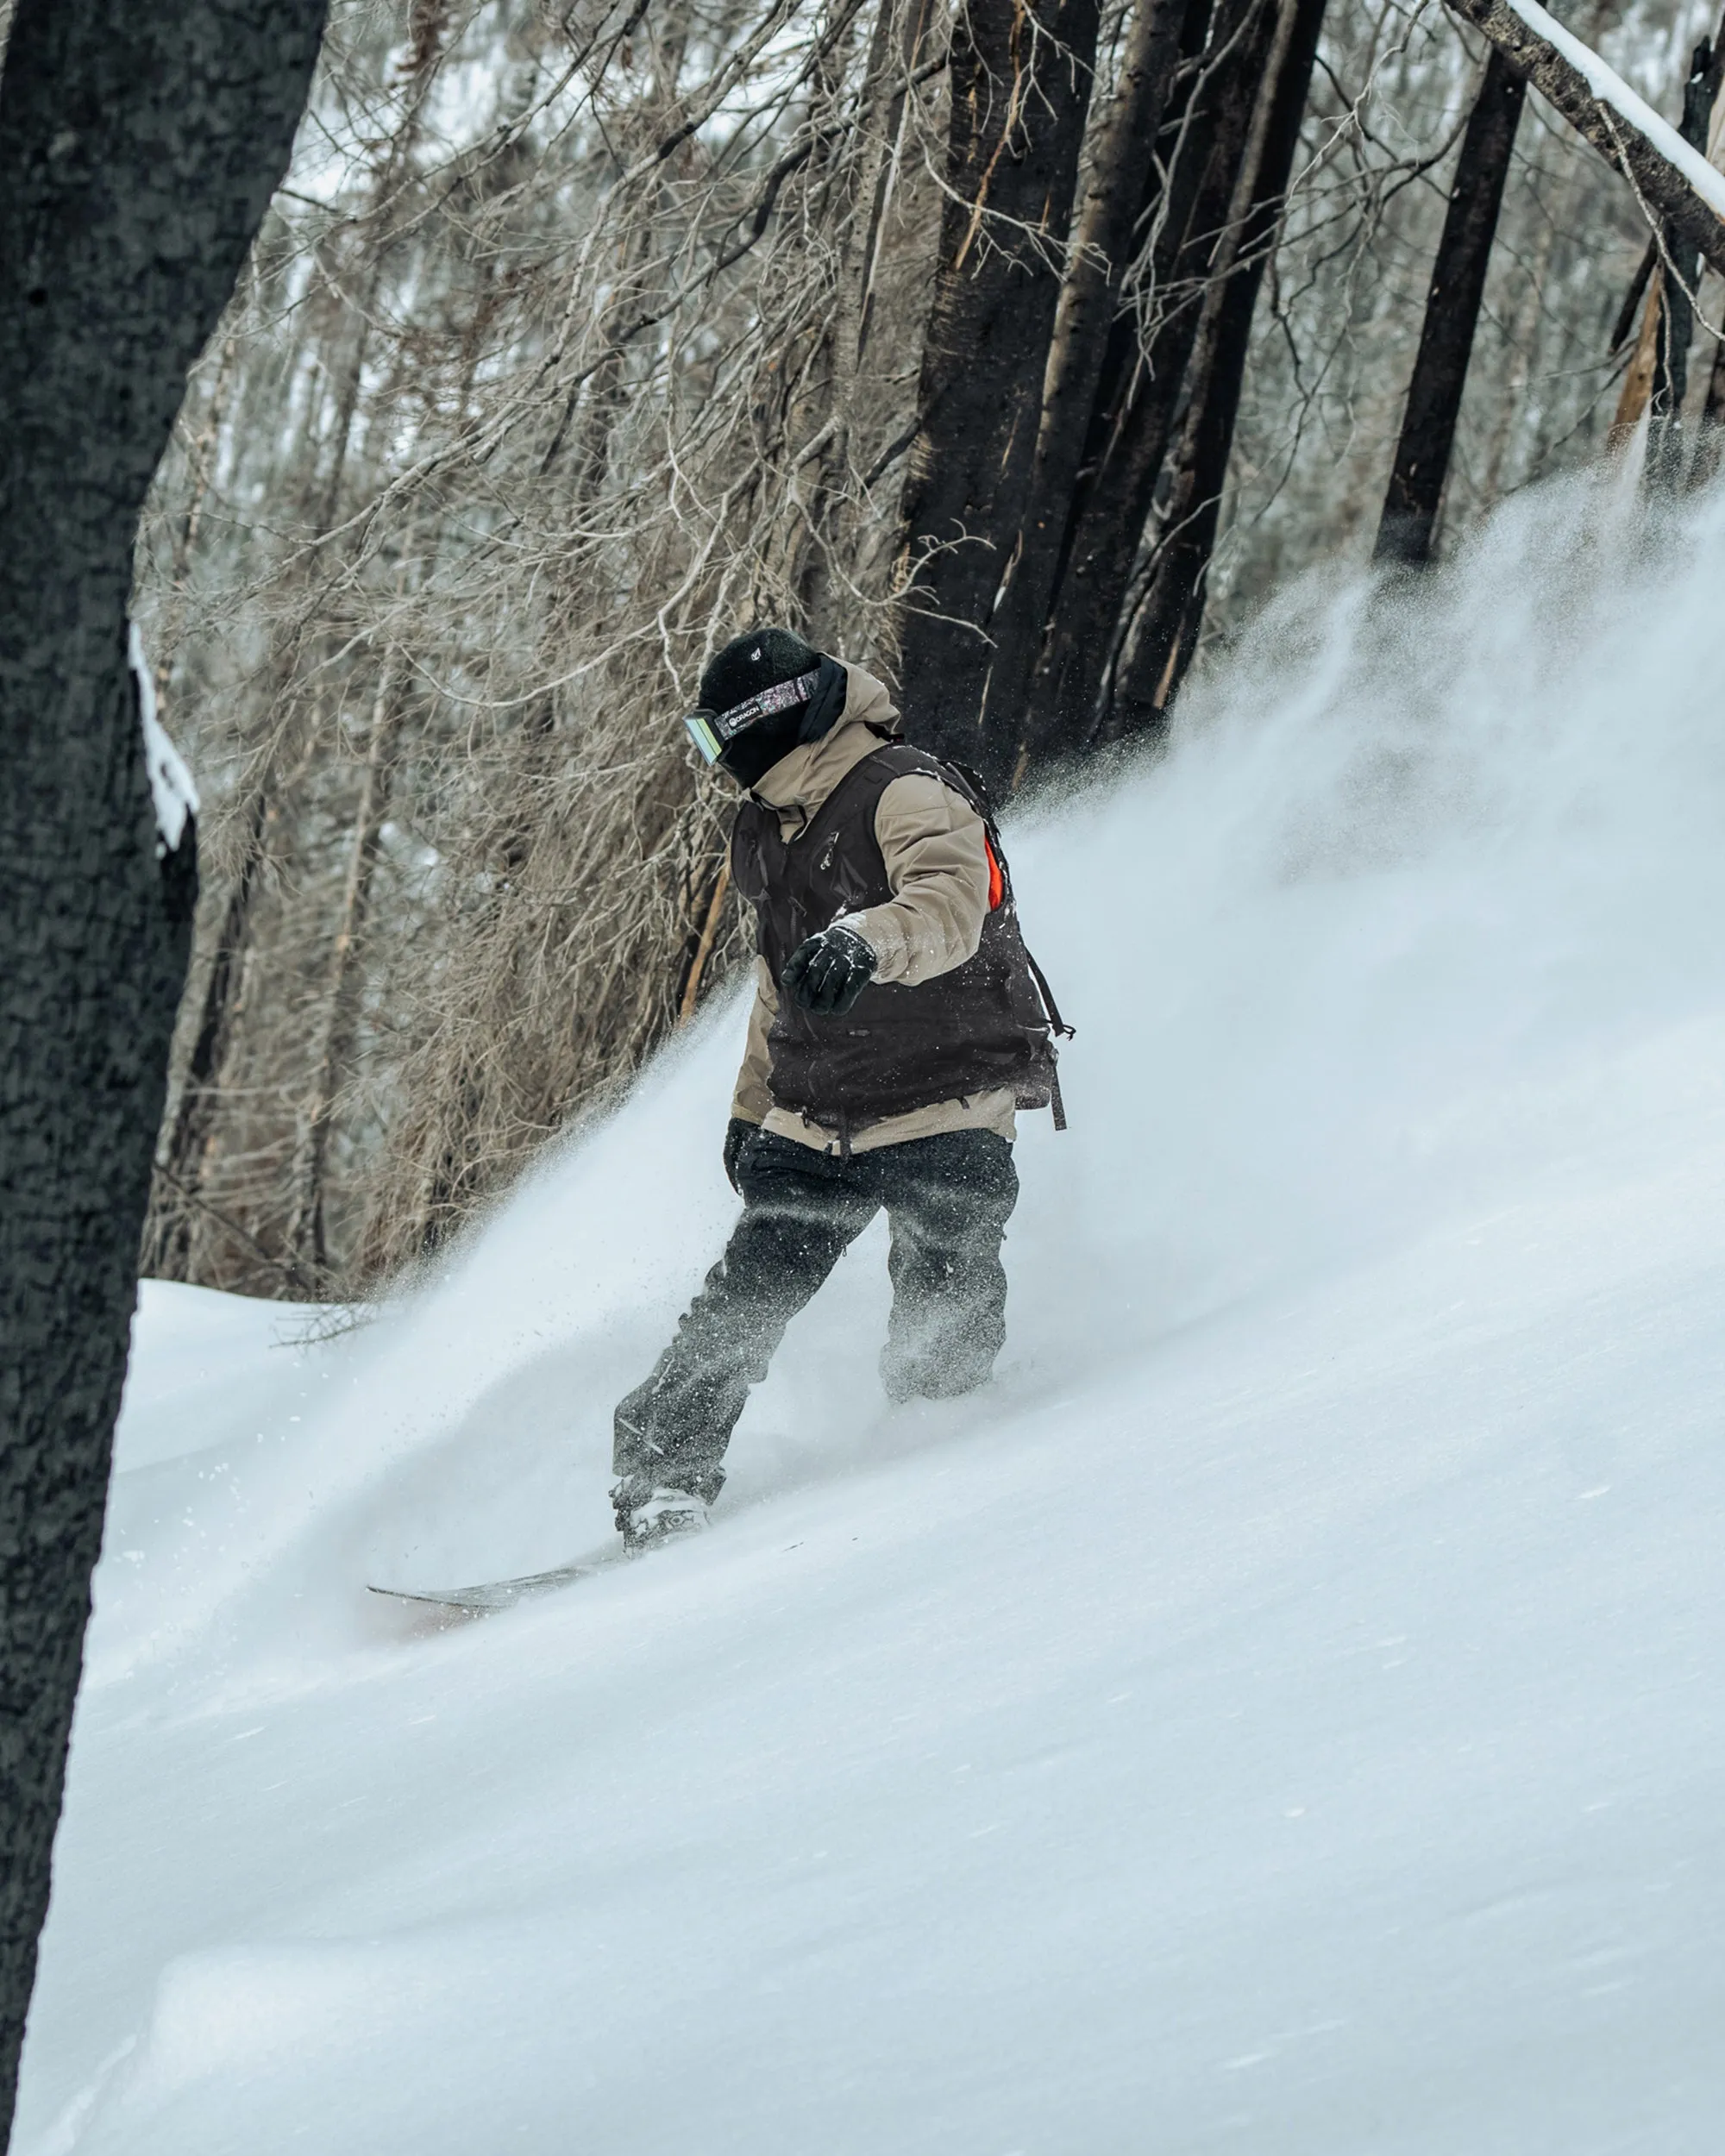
731;667;1018;1154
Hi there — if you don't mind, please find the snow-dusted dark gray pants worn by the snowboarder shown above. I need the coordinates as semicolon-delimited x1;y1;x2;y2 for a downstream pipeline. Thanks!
612;1130;1018;1518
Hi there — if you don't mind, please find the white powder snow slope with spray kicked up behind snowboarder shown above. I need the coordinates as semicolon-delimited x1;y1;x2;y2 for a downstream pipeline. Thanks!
16;490;1725;2156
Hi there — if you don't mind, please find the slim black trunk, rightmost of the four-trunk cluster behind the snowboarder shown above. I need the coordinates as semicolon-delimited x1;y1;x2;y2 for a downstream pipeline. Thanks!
1111;0;1324;737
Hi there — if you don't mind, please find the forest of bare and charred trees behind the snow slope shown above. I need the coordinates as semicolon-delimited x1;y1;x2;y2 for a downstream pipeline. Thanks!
114;0;1725;1305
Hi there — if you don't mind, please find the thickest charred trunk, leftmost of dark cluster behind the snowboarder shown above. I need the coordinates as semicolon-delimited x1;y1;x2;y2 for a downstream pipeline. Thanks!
901;0;1100;780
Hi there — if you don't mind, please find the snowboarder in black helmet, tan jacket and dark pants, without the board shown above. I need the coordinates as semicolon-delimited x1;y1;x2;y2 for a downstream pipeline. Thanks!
612;628;1065;1551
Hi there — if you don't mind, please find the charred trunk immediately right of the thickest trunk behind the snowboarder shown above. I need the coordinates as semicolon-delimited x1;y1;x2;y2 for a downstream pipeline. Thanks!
982;0;1208;785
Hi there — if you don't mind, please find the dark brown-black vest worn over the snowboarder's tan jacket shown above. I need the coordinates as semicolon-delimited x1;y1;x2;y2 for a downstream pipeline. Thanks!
731;742;1055;1132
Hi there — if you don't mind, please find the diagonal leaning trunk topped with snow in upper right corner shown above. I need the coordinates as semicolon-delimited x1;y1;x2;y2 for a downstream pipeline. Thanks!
1447;0;1725;274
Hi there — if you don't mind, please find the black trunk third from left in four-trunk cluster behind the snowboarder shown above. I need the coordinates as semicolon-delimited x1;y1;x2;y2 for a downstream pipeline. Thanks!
1025;0;1276;763
